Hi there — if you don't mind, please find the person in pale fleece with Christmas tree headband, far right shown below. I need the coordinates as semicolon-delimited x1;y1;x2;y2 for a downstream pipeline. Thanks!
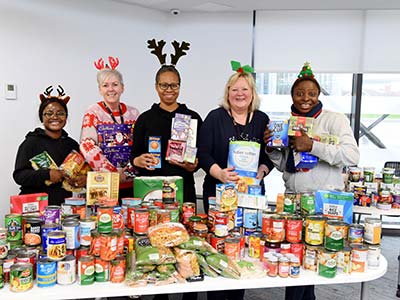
264;63;360;300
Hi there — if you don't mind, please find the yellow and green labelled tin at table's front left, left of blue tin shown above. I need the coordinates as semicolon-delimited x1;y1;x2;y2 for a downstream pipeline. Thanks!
10;263;33;292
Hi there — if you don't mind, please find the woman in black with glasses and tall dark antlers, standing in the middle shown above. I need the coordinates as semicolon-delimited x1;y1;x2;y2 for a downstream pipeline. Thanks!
132;39;202;207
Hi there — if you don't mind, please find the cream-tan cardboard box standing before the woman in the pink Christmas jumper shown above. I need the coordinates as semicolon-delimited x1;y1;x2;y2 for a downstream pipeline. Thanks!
86;172;119;205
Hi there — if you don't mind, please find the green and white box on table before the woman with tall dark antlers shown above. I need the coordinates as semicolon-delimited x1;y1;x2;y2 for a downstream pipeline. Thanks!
133;176;184;207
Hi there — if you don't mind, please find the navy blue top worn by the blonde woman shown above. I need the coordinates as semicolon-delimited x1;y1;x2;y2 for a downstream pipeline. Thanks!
198;107;273;209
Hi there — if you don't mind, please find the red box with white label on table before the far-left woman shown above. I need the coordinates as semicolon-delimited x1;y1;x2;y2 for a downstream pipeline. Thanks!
10;193;48;214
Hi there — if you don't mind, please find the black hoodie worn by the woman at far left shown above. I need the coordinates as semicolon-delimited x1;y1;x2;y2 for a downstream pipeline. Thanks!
13;128;79;205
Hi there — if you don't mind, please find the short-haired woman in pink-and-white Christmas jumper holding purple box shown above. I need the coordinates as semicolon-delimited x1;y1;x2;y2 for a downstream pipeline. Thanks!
80;56;139;198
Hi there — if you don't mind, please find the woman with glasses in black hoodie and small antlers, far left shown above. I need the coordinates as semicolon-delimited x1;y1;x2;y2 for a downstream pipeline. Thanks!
13;86;86;205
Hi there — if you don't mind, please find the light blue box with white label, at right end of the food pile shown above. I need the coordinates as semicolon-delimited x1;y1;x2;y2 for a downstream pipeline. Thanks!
315;190;354;224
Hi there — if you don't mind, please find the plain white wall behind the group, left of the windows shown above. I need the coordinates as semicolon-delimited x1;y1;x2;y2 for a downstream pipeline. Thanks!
0;0;252;227
